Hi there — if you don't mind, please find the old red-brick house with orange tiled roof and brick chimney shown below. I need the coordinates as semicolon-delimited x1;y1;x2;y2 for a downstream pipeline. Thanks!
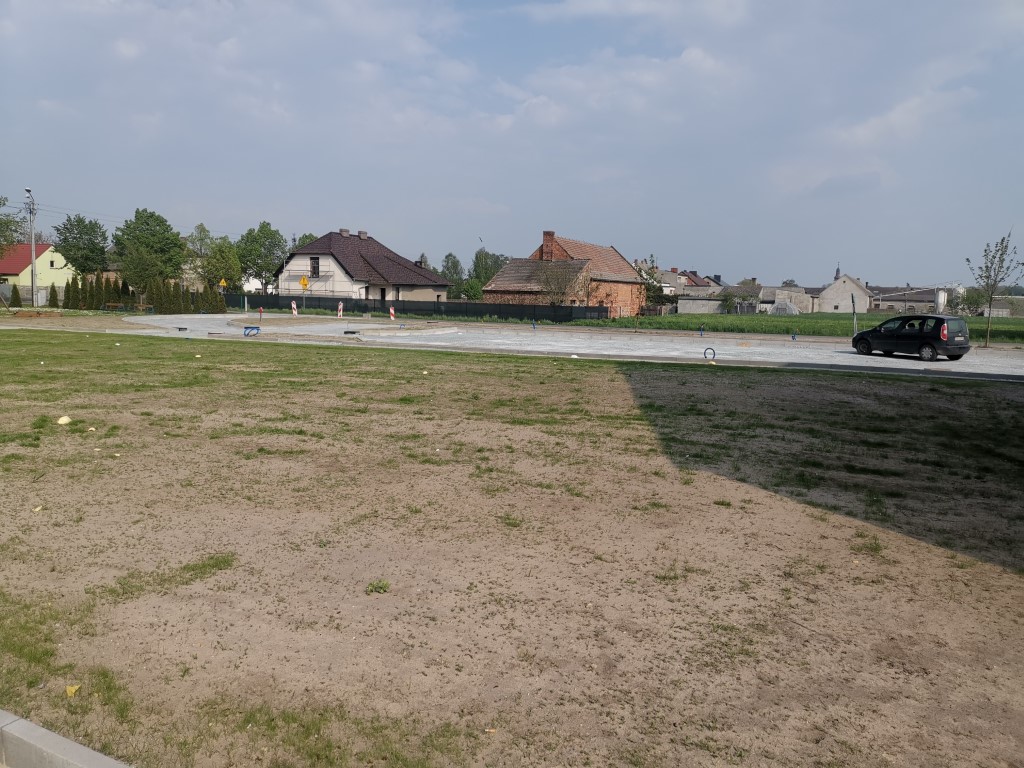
483;230;647;317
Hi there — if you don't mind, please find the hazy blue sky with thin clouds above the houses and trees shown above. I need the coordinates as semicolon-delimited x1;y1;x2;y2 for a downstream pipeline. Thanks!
0;0;1024;286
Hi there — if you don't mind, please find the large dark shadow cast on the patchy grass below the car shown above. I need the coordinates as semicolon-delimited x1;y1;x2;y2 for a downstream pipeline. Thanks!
622;365;1024;573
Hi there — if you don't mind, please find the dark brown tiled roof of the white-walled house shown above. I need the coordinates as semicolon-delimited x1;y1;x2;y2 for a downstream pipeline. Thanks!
276;231;449;287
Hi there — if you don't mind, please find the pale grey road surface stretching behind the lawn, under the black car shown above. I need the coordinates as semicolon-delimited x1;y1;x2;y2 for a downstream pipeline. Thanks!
119;313;1024;383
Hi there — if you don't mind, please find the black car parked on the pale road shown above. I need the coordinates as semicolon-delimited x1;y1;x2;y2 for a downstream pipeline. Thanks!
853;314;971;360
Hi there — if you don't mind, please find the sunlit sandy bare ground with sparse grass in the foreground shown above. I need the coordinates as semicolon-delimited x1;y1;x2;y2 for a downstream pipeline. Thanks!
0;325;1024;767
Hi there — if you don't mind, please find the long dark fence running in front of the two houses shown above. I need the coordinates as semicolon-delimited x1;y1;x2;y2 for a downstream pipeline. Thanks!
224;293;608;323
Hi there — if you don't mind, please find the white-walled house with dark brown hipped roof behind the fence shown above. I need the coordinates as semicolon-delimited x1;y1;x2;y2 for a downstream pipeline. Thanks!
274;229;449;301
